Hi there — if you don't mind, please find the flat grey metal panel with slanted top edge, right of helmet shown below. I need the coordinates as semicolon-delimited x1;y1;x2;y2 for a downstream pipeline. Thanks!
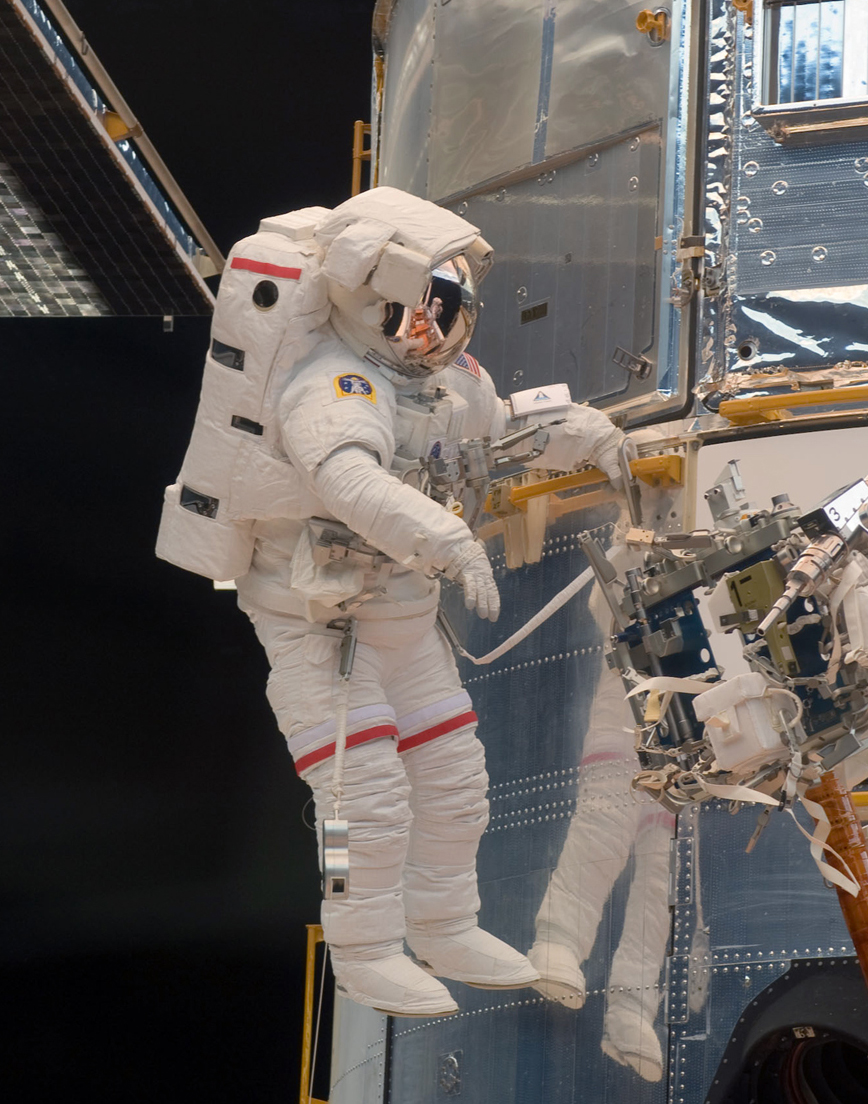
446;129;660;403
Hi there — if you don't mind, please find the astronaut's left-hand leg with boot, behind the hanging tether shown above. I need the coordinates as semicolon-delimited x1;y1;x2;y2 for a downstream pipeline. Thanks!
241;611;457;1016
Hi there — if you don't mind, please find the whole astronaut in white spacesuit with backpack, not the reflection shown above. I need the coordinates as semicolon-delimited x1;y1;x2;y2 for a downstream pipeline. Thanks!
158;188;621;1016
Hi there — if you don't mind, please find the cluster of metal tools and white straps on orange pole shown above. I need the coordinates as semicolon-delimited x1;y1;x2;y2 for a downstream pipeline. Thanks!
591;461;868;980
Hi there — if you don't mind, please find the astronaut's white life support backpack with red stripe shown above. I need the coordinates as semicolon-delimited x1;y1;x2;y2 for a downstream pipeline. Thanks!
157;208;331;580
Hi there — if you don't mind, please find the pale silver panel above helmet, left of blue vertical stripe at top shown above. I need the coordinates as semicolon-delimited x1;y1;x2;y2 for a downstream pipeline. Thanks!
426;0;546;200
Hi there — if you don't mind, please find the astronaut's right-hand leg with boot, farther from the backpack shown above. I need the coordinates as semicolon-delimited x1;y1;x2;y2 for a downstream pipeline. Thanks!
390;628;538;988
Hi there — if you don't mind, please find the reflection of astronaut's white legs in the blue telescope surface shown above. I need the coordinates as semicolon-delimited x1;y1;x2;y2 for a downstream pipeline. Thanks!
528;514;675;1081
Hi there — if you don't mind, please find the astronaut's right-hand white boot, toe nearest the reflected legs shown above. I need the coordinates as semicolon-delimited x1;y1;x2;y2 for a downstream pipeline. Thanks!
406;920;539;989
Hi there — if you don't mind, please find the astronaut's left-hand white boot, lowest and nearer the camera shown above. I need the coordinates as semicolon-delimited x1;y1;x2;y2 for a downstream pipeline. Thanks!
329;947;458;1016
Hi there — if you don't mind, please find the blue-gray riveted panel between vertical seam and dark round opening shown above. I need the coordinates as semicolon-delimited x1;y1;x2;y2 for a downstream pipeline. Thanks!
669;800;854;1104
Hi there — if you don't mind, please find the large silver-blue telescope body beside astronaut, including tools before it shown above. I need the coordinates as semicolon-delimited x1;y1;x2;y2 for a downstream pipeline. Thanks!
320;0;868;1104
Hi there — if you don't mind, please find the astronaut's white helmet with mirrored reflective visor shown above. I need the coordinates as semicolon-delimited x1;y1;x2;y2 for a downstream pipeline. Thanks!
317;188;491;379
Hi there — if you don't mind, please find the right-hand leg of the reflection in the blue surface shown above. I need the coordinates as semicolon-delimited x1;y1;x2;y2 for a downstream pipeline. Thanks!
602;805;675;1081
